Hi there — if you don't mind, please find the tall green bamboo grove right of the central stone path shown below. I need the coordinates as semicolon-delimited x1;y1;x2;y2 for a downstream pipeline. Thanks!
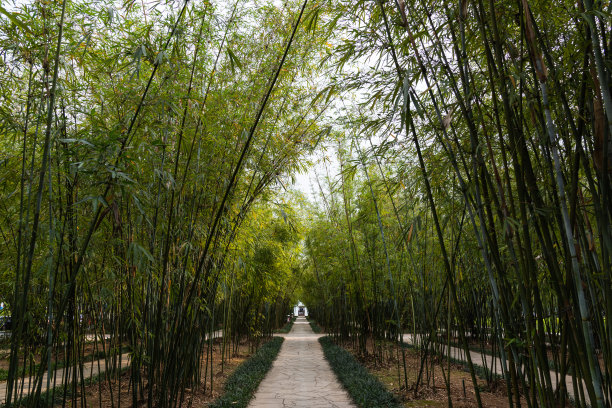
304;0;612;407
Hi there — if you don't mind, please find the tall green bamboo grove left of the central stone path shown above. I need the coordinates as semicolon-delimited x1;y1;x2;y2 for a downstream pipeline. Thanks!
0;0;324;407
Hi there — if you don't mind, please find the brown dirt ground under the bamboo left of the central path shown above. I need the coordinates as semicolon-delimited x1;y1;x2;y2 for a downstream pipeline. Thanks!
54;339;252;408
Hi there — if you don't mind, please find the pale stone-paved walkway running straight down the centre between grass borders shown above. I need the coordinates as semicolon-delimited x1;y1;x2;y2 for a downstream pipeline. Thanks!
249;317;355;408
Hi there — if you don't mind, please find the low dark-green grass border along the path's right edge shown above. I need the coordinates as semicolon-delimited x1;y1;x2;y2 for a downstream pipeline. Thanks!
319;336;402;408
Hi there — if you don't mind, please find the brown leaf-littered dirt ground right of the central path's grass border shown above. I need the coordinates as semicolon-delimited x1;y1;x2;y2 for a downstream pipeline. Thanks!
344;338;526;408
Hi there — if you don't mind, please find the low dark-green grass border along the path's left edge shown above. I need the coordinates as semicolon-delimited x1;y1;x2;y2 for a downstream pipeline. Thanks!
209;337;284;408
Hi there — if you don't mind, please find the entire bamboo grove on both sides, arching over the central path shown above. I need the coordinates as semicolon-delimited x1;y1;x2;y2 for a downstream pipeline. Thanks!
0;0;612;408
